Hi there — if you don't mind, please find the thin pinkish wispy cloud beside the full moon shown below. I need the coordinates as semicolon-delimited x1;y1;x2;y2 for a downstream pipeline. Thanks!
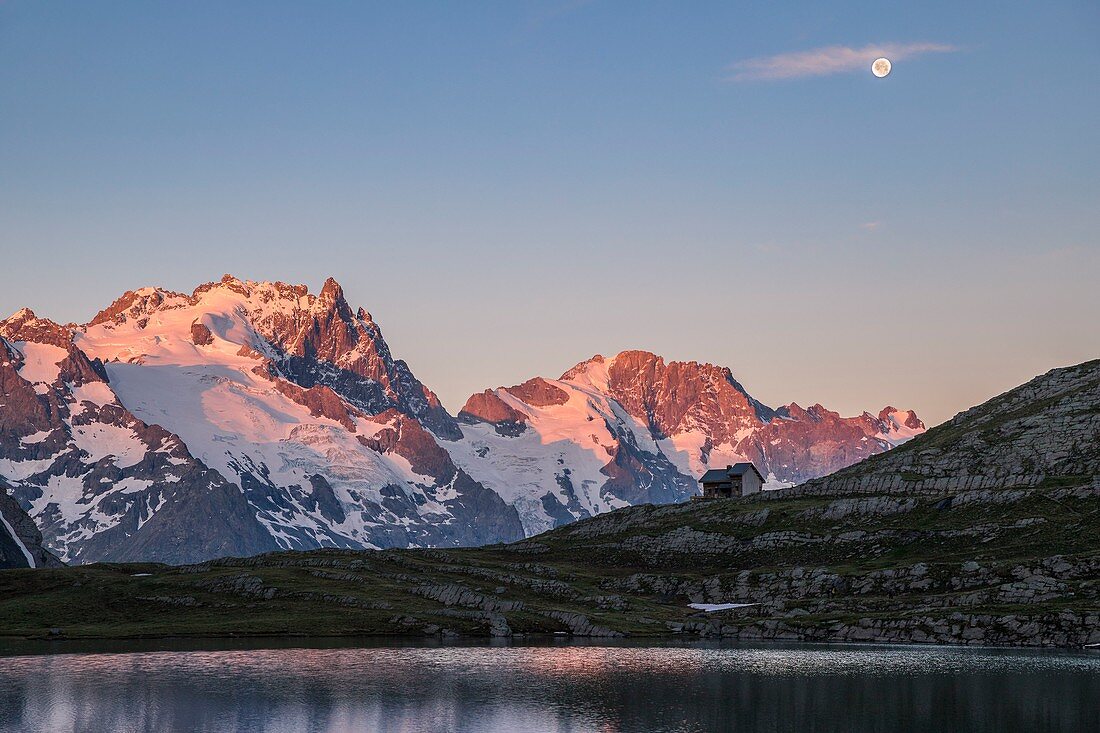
728;43;956;81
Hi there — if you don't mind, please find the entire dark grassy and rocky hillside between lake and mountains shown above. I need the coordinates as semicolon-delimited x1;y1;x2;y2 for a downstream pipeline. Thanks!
0;362;1100;646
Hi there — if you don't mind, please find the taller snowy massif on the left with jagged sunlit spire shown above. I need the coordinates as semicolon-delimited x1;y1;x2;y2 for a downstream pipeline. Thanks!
0;276;523;562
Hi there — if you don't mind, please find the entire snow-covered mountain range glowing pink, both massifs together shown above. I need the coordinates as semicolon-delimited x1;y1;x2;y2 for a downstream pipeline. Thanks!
0;270;924;565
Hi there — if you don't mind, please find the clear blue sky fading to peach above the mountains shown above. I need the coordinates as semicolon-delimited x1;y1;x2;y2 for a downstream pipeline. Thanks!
0;0;1100;425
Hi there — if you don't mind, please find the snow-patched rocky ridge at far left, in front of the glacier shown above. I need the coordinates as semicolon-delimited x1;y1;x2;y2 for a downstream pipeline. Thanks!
0;310;278;562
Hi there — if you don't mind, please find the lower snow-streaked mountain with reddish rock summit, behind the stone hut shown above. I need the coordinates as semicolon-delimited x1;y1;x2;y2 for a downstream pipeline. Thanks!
451;351;924;534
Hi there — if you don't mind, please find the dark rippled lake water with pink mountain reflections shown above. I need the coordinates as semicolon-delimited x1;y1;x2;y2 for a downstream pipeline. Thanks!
0;644;1100;733
